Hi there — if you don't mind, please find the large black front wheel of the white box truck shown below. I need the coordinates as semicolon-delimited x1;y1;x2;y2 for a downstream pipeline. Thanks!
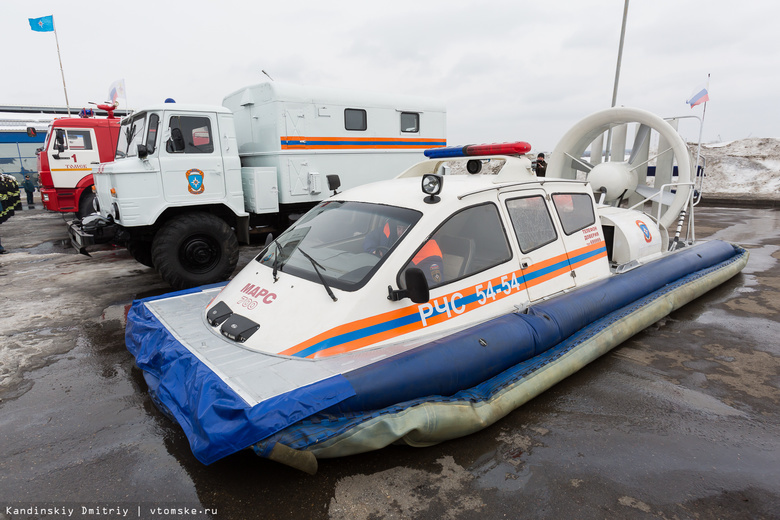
152;213;238;289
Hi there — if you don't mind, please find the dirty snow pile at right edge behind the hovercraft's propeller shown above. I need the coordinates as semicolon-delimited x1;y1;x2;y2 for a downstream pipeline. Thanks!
689;138;780;197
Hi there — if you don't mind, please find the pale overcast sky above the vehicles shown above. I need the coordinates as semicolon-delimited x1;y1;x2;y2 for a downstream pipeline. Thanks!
0;0;780;151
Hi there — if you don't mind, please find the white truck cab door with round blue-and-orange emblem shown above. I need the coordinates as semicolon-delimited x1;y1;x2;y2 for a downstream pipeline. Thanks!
160;112;225;203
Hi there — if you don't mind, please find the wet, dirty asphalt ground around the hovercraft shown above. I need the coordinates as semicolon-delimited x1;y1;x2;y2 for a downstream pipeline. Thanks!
0;207;780;520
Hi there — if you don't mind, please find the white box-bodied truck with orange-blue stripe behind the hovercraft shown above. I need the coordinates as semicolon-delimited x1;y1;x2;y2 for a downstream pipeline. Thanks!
69;82;446;288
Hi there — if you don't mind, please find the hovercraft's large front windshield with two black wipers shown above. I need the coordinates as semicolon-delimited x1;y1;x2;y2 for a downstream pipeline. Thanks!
255;201;422;291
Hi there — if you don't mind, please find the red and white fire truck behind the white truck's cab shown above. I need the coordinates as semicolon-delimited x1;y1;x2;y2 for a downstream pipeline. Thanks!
38;105;120;218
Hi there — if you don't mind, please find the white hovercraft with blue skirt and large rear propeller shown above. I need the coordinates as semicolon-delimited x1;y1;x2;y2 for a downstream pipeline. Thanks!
126;108;748;473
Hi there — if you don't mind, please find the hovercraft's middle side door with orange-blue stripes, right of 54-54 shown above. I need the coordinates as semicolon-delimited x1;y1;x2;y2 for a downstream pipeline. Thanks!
501;190;574;301
